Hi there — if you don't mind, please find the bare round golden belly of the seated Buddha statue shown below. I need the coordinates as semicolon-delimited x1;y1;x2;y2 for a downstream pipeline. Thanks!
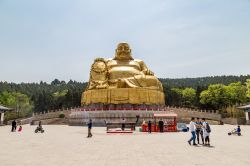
109;66;140;80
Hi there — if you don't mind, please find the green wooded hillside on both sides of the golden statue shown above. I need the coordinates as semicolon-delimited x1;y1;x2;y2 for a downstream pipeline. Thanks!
0;75;250;120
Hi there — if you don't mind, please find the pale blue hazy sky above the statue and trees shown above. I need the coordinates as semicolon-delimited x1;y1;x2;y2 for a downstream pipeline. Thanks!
0;0;250;83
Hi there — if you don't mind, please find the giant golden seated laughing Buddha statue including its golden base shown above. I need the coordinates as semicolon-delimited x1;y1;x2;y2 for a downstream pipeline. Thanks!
82;43;165;105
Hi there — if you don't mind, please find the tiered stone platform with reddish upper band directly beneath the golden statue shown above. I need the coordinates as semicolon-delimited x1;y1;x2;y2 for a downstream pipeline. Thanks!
69;104;167;126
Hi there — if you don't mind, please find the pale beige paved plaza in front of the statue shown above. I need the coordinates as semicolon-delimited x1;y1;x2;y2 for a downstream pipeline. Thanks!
0;125;250;166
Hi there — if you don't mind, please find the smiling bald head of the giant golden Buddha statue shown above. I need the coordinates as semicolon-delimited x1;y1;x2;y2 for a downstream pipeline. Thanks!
115;43;133;60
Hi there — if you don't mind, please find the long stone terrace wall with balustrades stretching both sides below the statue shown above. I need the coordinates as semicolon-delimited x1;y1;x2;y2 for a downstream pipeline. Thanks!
29;107;221;126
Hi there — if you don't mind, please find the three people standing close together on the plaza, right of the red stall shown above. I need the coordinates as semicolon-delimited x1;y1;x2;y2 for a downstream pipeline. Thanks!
188;117;211;146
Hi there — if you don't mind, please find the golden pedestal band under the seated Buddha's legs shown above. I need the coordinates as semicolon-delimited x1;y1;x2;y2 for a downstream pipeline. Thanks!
81;88;165;105
